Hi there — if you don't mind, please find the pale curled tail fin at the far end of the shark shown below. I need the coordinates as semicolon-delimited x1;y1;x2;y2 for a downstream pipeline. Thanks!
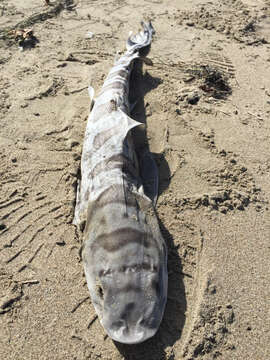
126;21;155;55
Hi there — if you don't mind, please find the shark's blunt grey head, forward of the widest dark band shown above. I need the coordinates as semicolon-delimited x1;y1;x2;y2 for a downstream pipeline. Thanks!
84;226;167;344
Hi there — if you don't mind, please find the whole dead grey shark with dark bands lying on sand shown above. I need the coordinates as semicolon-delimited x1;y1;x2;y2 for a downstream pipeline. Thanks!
74;23;168;344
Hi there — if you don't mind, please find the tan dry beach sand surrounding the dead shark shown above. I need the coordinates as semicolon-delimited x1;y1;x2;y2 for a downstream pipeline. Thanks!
0;0;270;360
